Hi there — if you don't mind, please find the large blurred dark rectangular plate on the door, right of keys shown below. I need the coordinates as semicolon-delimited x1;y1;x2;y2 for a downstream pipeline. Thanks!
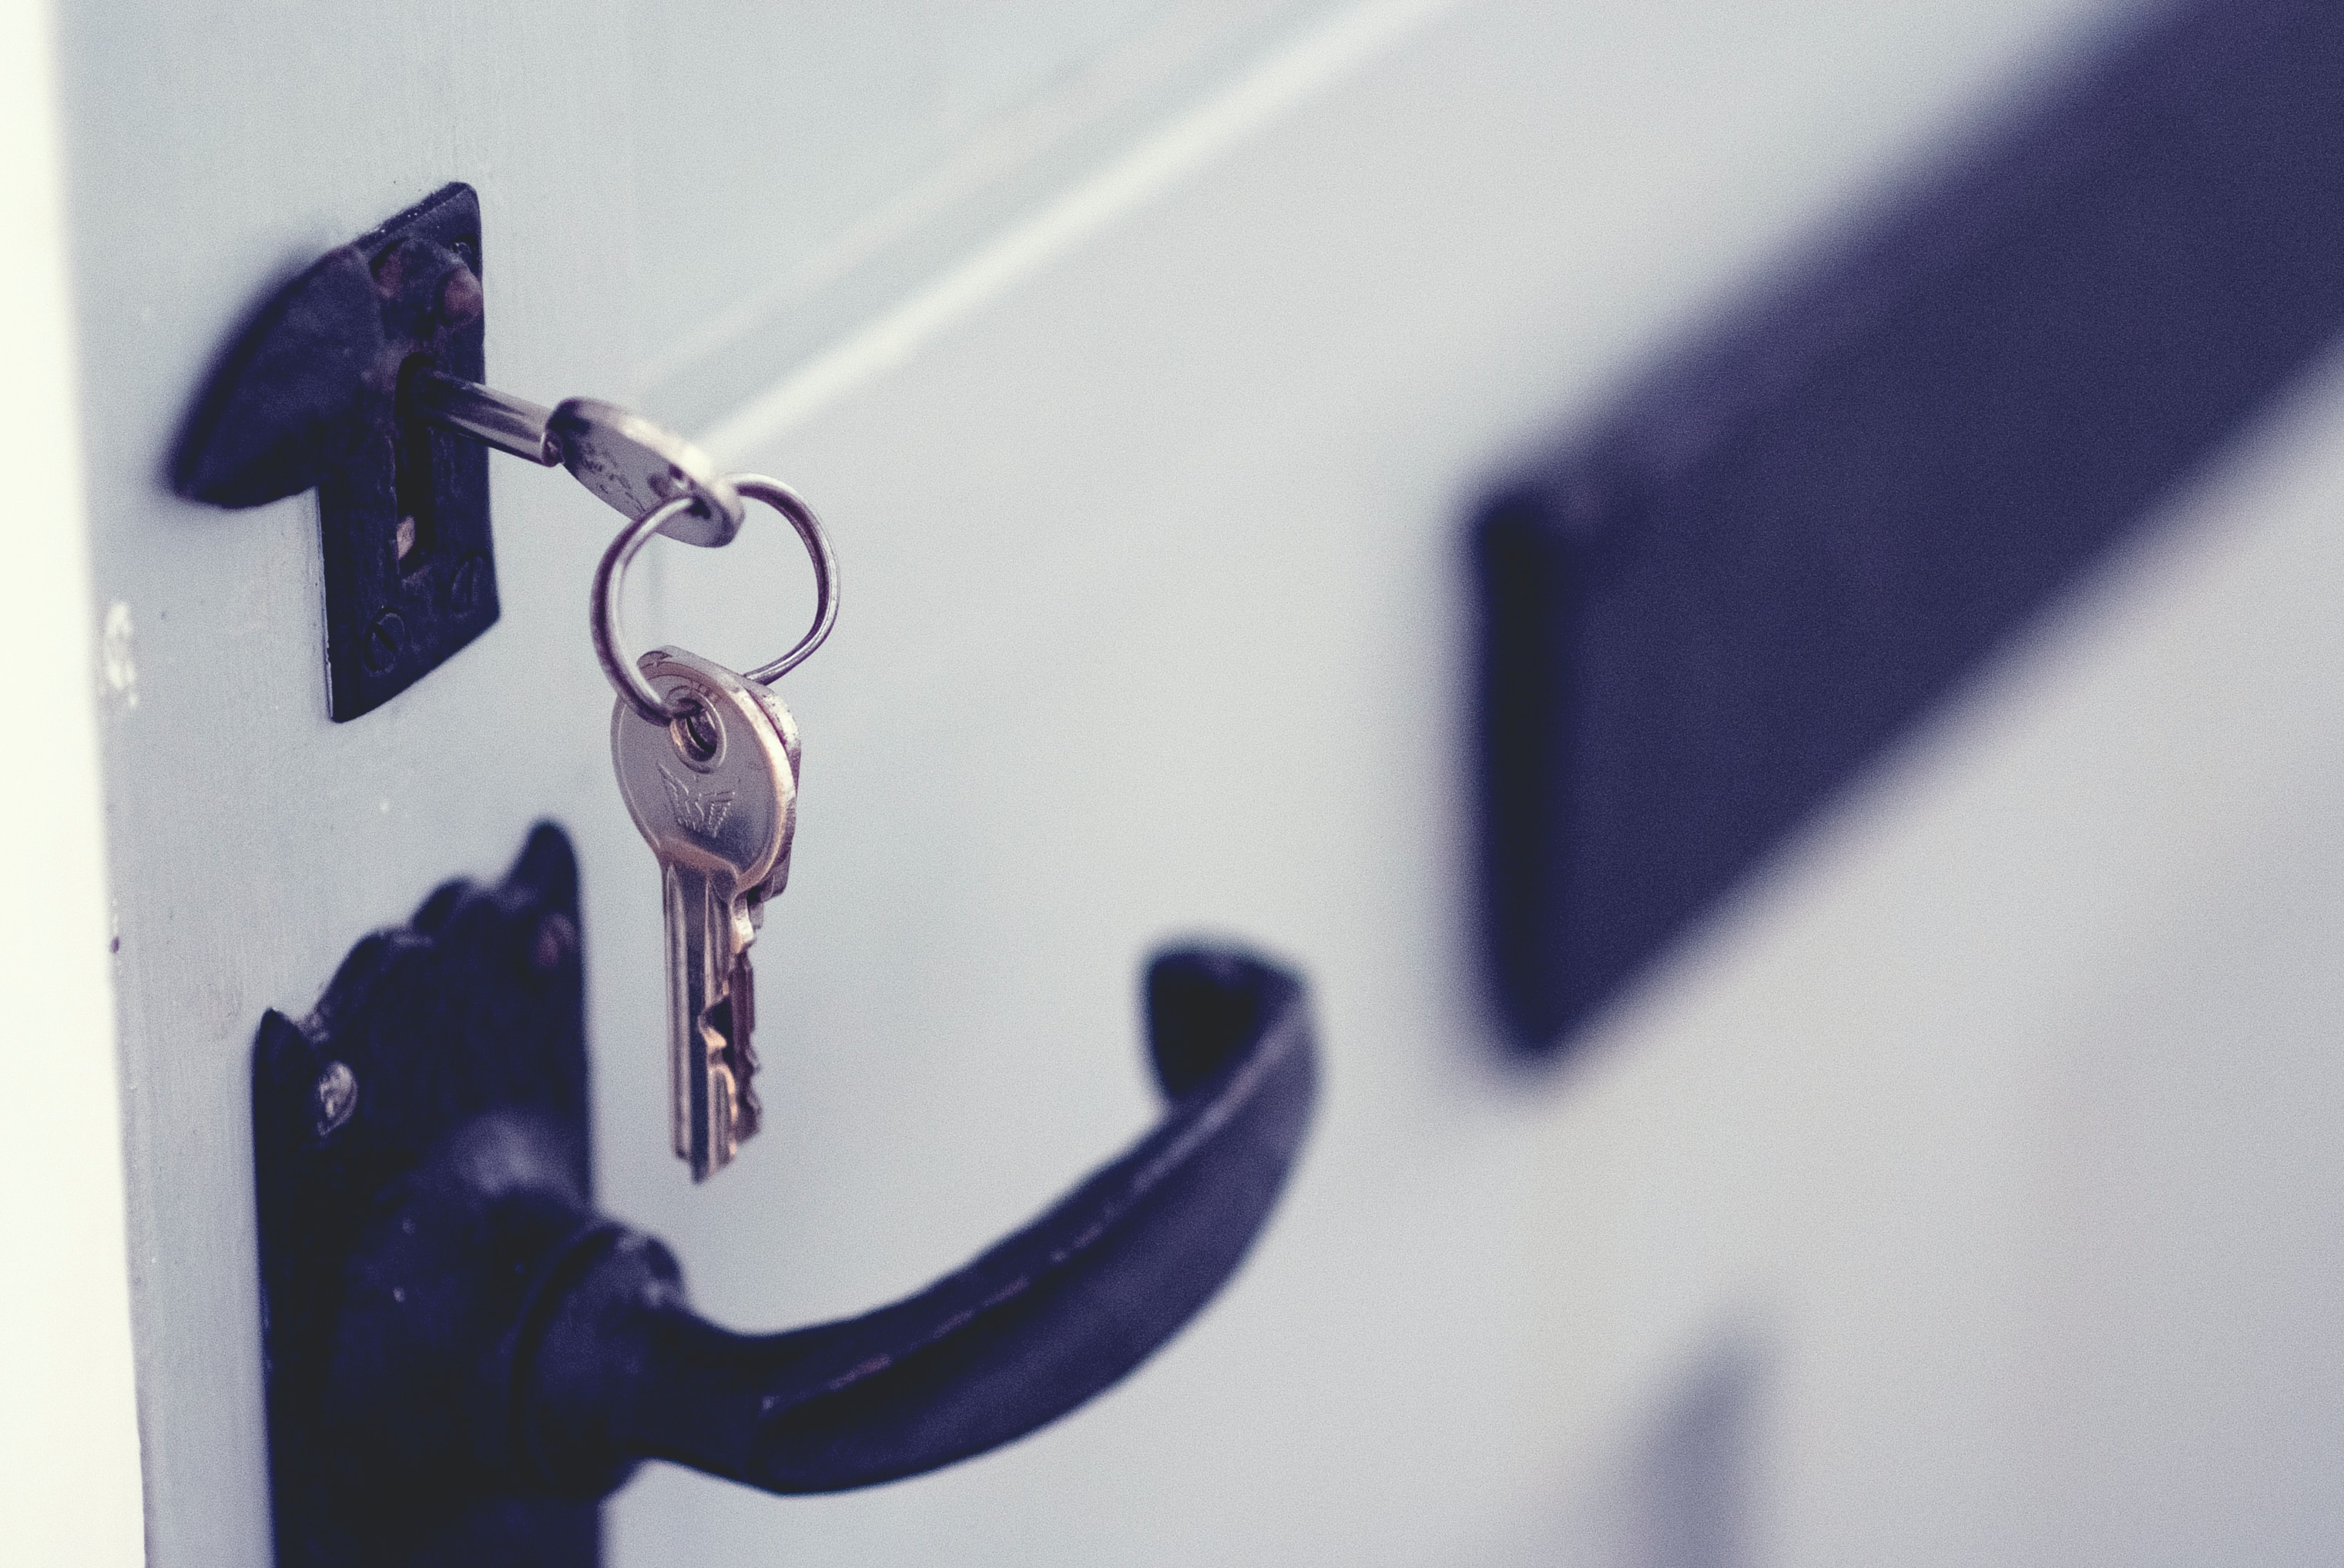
1474;0;2344;1050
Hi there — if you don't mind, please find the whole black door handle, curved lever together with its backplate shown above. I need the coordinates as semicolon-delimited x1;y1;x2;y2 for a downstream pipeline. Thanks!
253;827;1317;1568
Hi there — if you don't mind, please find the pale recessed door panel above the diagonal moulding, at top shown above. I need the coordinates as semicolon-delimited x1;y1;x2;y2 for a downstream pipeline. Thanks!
619;0;1376;429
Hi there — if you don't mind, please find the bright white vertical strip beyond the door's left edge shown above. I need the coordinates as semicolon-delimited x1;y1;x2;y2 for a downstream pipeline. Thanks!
0;5;146;1566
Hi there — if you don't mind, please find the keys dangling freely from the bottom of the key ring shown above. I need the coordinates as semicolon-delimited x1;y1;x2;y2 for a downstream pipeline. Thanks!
612;649;797;1181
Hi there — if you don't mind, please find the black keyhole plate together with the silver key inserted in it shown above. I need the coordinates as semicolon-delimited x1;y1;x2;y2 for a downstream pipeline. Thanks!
171;183;746;719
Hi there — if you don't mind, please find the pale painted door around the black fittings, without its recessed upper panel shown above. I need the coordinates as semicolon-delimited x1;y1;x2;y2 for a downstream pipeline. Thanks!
65;0;2344;1568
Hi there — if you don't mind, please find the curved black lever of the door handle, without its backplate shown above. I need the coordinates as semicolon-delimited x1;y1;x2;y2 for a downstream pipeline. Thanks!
523;928;1313;1493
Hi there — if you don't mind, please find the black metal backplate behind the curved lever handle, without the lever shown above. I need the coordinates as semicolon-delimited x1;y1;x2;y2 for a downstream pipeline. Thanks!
253;825;600;1568
